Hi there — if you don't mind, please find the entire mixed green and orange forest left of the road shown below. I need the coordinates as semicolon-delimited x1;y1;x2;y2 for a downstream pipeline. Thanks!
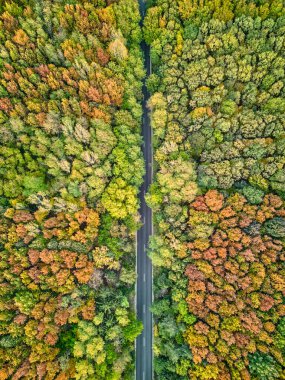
0;0;144;380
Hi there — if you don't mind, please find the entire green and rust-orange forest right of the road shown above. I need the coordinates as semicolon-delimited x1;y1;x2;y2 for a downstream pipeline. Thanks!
144;0;285;380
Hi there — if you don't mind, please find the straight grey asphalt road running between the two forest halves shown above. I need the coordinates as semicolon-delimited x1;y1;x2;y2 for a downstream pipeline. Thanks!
136;0;153;380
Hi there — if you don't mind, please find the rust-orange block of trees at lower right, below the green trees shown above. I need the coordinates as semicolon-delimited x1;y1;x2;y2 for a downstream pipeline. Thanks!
185;190;285;379
